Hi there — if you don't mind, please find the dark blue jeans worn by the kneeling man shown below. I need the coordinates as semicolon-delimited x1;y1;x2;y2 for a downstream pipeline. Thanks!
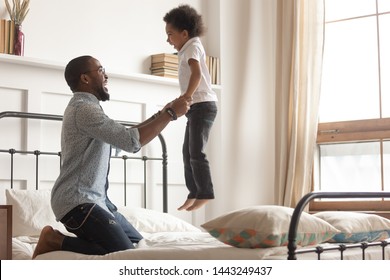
61;203;143;255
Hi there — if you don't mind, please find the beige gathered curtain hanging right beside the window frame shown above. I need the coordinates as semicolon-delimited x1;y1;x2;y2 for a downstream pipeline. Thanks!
275;0;324;207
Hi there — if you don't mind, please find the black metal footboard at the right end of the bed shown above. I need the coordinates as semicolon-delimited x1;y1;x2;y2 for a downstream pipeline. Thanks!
287;192;390;260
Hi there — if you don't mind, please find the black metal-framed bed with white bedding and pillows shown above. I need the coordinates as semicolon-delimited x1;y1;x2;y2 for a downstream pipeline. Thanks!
0;112;390;260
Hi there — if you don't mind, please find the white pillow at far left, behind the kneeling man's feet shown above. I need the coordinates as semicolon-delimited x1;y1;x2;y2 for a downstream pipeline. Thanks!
5;189;67;237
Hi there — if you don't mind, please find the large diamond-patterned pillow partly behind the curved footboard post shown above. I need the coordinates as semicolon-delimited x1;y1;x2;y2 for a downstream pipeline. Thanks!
202;205;338;248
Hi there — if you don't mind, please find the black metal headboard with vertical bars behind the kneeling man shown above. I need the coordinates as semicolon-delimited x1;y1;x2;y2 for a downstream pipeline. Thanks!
0;111;168;213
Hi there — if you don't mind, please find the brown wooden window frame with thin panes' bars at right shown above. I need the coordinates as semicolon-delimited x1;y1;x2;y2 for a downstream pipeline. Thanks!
309;1;390;214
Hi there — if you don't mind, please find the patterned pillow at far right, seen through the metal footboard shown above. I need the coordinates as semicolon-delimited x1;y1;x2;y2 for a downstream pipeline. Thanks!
314;211;390;243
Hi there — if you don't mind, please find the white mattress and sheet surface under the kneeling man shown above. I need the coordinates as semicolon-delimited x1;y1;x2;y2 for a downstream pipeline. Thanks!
13;232;390;260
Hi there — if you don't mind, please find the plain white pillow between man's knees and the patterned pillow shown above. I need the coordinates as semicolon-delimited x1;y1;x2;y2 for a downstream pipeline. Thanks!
118;206;201;233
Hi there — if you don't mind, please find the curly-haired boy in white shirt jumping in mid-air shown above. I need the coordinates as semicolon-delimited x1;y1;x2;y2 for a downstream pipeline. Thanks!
163;5;217;211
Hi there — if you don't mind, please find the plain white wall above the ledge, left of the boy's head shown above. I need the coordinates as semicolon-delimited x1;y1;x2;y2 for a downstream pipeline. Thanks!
0;0;210;74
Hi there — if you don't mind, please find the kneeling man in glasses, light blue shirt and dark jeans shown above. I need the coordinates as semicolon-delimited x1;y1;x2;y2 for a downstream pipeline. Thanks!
33;56;189;258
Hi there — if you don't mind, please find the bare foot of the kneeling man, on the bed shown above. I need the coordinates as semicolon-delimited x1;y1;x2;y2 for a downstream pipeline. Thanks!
32;226;65;259
